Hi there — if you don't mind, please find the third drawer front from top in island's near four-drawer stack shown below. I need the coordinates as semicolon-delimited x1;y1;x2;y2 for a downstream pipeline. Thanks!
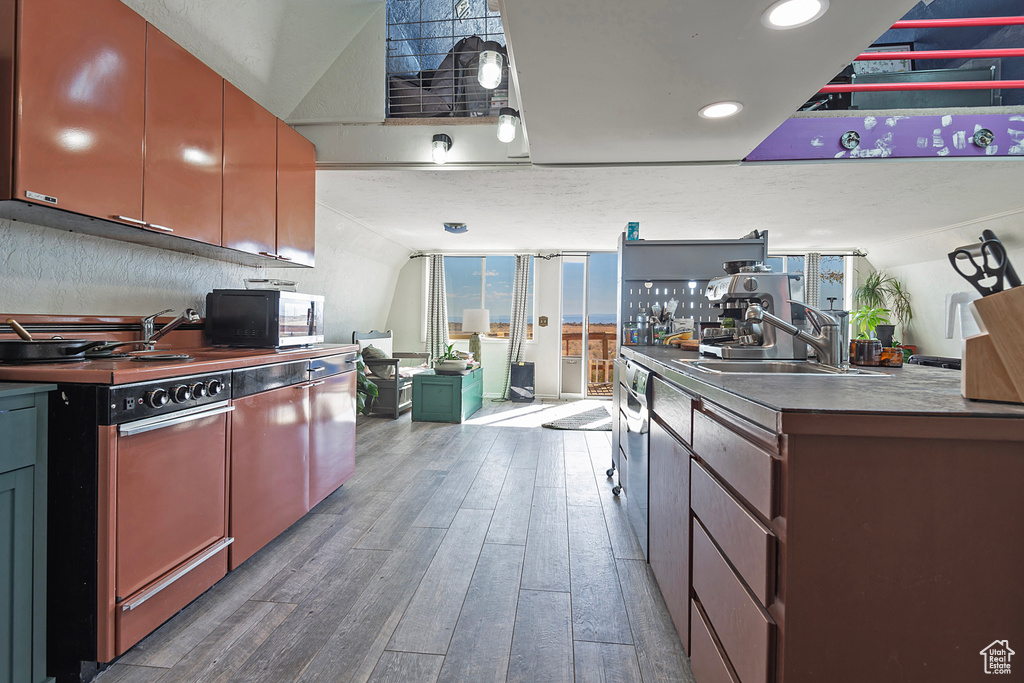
693;519;774;683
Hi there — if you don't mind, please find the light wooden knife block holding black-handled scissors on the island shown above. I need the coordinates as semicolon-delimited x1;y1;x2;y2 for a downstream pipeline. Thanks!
961;287;1024;403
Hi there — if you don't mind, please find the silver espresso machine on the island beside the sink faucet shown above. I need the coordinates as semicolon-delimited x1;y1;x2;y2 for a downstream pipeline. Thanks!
699;263;807;360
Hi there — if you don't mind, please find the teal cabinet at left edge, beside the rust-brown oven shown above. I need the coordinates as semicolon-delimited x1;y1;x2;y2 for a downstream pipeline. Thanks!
0;383;55;683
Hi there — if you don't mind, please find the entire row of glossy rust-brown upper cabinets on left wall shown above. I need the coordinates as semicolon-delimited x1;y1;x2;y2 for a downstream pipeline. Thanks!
0;0;315;266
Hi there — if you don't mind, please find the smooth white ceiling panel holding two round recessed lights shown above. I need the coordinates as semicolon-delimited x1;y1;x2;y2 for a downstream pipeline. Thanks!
503;0;915;164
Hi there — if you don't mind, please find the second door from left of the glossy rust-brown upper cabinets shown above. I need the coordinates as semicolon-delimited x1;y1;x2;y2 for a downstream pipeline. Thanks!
142;25;224;245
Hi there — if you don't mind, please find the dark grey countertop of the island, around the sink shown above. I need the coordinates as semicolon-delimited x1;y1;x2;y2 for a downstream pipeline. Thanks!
622;346;1024;428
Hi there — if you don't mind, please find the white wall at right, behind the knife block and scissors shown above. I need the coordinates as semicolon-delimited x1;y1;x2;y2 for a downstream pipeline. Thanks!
867;214;1024;357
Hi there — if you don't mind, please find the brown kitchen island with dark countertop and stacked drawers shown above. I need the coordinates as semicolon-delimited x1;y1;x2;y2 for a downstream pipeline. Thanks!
623;347;1024;683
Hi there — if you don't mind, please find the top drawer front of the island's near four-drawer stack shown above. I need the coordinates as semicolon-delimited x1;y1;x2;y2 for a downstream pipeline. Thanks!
693;412;774;519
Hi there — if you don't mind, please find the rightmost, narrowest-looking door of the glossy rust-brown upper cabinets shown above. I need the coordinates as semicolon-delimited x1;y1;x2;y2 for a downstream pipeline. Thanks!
276;120;316;266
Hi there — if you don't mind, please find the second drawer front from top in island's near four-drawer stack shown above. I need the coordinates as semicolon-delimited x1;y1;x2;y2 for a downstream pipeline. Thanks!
690;462;775;605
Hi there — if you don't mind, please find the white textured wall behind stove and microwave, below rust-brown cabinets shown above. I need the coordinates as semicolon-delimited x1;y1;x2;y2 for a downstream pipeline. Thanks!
0;205;409;342
